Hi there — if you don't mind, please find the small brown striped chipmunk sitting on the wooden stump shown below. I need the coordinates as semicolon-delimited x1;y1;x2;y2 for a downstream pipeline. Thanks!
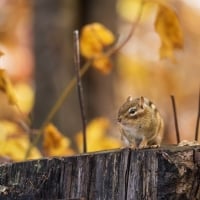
118;97;164;148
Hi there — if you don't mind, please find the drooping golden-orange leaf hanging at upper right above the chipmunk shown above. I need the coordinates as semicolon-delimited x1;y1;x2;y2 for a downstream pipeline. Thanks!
155;5;183;60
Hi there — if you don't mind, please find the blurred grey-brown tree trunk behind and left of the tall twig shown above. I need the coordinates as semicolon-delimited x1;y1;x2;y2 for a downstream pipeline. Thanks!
33;0;81;135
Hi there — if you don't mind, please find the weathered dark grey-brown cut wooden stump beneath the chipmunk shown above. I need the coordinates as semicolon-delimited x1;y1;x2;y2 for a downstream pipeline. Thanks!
0;146;200;200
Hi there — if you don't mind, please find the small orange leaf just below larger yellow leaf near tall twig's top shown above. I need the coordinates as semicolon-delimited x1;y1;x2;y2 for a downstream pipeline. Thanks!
92;55;112;74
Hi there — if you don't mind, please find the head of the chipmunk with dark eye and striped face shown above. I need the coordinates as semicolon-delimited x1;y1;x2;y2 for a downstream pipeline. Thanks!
118;96;148;127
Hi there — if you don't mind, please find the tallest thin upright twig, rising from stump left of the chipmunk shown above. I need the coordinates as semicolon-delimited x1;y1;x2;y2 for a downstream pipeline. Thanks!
74;30;87;153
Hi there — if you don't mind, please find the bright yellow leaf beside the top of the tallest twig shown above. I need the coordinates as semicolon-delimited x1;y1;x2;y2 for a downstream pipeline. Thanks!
80;23;115;59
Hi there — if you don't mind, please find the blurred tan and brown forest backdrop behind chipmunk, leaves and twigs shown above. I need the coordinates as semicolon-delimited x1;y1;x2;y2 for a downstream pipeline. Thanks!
0;0;200;158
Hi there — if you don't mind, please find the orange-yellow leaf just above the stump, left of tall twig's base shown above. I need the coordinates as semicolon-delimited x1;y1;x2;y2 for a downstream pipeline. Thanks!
43;124;74;156
